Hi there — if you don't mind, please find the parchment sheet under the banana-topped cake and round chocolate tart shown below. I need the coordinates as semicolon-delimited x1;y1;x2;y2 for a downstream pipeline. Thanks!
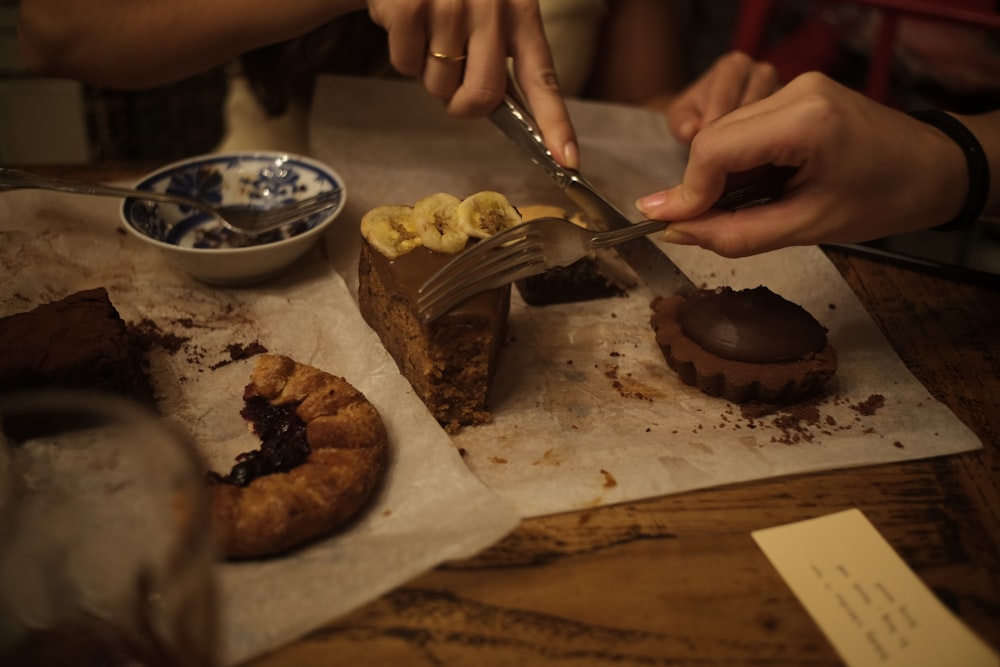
311;77;981;516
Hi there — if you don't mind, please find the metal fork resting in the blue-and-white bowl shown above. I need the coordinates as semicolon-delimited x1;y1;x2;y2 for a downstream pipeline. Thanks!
0;167;343;236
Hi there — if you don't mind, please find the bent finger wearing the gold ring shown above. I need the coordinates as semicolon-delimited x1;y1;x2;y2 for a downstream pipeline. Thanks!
421;0;469;102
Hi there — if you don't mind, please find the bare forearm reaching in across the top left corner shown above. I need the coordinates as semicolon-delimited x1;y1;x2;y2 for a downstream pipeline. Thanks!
18;0;365;88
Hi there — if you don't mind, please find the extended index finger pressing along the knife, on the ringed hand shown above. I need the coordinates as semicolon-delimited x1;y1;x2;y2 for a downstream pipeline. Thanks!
509;3;580;169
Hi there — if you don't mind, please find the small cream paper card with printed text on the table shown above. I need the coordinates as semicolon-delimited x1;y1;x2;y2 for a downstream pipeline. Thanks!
752;510;1000;667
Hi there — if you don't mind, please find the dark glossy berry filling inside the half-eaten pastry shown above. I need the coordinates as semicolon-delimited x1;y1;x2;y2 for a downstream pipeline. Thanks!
214;396;311;486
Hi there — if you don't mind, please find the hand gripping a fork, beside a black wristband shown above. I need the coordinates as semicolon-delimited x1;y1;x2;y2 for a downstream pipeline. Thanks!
636;73;968;257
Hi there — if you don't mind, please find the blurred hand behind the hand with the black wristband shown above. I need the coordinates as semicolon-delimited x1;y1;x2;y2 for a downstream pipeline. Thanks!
666;51;780;144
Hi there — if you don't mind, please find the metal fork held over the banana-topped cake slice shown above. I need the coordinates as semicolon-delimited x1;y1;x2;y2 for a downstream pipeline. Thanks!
417;218;667;322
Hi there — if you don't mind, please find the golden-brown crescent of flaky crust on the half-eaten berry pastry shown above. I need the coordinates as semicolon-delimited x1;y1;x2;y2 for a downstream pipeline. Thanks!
210;355;389;558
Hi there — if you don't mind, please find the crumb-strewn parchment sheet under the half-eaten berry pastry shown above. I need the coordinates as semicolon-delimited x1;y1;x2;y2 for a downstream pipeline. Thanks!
0;191;518;664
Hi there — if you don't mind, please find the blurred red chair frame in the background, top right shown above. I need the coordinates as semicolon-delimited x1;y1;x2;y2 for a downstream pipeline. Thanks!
731;0;1000;102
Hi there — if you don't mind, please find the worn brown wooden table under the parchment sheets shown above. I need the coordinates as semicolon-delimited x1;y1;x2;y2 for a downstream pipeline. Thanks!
31;165;1000;667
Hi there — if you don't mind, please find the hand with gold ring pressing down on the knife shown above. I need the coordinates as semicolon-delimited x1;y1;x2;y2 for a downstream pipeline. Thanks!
368;0;579;168
